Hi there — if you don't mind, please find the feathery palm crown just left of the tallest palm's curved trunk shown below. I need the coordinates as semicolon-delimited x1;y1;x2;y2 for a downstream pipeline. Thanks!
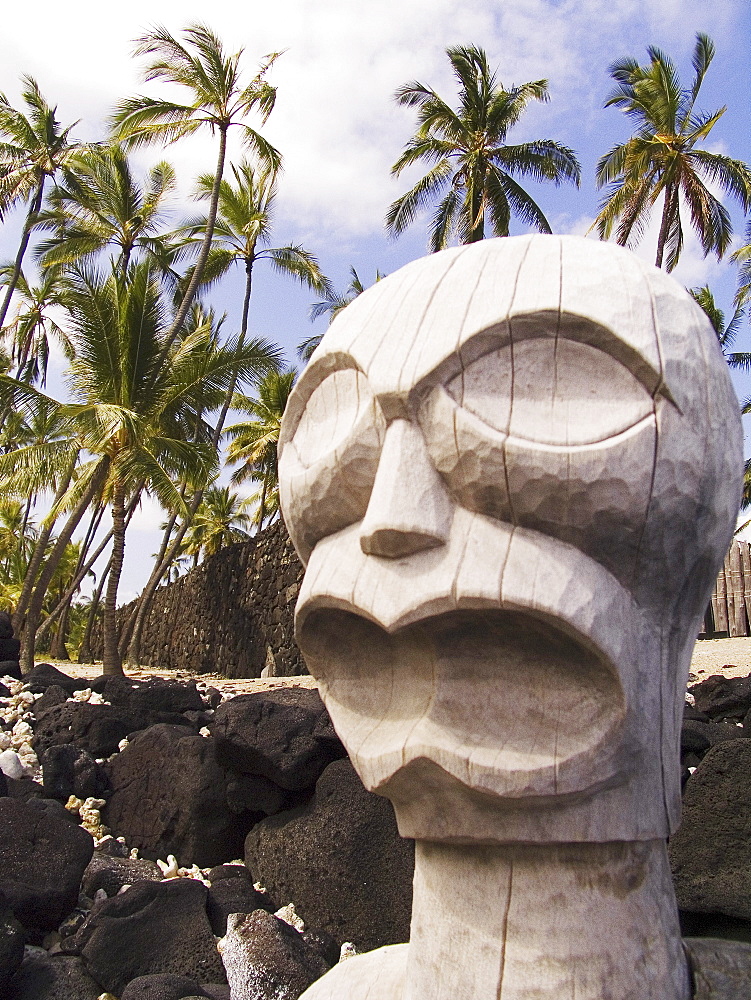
36;144;184;278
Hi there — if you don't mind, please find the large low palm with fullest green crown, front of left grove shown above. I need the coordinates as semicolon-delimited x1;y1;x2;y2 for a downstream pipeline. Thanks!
0;261;276;673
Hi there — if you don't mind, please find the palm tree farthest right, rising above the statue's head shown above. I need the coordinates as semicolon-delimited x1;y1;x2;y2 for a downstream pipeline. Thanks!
592;34;751;271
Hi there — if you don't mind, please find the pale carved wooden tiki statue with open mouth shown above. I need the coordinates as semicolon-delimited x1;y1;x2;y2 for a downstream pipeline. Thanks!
279;236;741;1000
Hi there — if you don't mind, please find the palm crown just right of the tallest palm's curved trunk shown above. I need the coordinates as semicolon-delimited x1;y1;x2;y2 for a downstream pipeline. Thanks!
180;160;331;333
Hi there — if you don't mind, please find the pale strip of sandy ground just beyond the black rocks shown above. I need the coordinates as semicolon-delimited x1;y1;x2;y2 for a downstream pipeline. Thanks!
36;637;751;695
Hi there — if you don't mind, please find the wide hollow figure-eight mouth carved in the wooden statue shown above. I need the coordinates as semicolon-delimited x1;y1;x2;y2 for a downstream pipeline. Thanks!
298;608;626;799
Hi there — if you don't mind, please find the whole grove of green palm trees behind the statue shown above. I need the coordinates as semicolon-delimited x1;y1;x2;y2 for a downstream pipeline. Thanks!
0;24;751;674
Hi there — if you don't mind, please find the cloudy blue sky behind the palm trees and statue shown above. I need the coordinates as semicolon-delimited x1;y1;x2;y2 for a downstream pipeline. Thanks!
0;0;751;599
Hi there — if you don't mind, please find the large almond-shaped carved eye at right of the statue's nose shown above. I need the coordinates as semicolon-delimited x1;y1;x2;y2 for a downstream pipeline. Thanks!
446;337;653;445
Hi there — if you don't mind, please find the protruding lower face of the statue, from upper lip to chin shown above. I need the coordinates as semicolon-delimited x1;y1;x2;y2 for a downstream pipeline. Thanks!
297;508;661;842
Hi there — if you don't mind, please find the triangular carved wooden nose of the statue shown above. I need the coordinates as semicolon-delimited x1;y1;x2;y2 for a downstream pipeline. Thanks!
360;419;453;559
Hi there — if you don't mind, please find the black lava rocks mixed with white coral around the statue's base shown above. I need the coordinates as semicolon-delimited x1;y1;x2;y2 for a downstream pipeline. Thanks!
0;664;751;1000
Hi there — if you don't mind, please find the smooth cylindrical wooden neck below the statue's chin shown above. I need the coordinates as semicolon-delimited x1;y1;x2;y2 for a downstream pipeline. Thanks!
404;840;691;1000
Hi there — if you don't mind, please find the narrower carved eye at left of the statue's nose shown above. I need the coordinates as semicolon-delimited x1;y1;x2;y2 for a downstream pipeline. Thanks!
293;368;374;468
